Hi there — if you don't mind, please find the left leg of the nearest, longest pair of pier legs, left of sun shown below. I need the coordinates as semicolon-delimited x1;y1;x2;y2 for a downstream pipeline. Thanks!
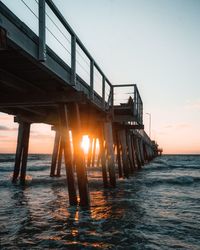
59;105;77;205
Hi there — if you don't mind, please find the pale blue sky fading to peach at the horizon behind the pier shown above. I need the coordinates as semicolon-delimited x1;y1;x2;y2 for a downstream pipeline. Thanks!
0;0;200;154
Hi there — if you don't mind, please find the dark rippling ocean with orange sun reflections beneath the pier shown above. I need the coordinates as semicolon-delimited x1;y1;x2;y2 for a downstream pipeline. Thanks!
0;154;200;250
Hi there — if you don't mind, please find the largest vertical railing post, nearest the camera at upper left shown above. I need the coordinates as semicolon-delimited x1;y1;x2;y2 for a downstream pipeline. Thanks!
38;0;46;62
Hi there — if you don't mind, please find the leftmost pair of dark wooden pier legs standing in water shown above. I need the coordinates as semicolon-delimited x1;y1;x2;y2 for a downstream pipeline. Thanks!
13;122;30;184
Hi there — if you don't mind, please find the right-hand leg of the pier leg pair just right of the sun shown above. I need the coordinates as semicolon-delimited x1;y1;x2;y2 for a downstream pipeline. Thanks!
104;122;116;187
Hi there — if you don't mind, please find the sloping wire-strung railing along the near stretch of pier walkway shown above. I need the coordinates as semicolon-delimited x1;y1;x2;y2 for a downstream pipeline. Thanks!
0;0;113;110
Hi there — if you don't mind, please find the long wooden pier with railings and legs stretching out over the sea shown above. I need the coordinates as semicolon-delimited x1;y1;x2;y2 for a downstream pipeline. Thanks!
0;0;158;206
